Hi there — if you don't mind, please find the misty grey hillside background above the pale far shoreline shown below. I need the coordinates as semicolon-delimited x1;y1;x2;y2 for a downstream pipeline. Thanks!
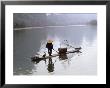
13;13;97;28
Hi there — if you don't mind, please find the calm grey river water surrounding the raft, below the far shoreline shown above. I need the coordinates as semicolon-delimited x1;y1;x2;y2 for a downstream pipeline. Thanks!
13;26;97;75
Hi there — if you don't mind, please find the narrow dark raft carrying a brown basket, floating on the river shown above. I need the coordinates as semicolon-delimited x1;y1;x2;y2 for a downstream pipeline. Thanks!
31;47;81;62
